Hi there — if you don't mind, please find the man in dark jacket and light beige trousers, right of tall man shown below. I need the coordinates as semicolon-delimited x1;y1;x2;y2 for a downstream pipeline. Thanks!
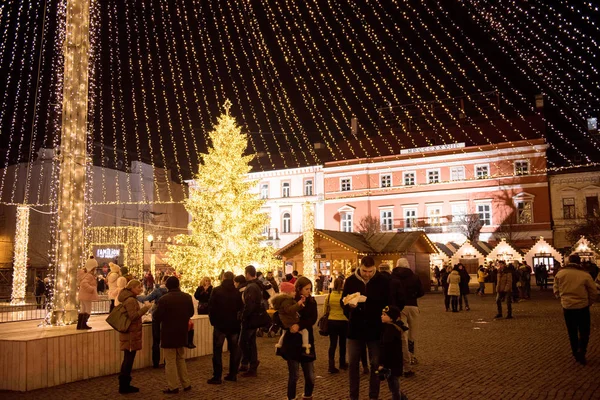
390;258;425;378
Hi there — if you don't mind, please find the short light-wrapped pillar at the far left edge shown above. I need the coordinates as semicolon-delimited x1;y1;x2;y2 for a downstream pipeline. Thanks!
10;206;29;305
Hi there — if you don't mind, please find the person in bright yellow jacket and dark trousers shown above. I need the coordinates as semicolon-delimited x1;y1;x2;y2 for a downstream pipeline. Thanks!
323;278;348;374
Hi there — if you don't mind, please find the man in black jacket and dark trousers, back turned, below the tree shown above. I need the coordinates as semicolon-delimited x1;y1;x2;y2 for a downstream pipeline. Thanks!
207;271;244;385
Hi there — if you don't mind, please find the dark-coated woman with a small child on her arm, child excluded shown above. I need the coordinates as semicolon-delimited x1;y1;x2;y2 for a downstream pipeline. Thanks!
278;276;318;400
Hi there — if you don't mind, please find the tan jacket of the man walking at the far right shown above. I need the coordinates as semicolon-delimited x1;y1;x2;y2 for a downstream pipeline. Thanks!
554;264;598;309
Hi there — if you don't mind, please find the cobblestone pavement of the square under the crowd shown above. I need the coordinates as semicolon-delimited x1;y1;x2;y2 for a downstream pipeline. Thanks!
0;291;600;400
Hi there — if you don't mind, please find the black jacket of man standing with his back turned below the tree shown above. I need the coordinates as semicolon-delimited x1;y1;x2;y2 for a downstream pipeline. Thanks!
208;279;244;334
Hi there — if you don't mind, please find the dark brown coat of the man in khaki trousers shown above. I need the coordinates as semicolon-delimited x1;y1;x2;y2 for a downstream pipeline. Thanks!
152;288;194;349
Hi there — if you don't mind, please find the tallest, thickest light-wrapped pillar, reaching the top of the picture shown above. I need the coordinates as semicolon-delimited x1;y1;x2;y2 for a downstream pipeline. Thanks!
52;0;90;325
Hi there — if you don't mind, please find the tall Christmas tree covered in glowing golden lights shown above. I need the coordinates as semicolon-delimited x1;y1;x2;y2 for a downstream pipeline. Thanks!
167;102;278;292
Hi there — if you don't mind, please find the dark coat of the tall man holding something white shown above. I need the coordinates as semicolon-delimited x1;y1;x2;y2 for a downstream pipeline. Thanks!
340;268;390;341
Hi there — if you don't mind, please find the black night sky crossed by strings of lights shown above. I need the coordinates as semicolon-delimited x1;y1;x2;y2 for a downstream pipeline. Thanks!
0;0;600;188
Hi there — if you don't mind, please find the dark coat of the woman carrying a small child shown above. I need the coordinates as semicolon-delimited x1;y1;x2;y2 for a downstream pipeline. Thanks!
278;295;319;362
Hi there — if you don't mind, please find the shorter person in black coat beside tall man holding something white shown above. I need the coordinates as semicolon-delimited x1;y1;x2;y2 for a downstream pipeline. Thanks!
378;305;406;400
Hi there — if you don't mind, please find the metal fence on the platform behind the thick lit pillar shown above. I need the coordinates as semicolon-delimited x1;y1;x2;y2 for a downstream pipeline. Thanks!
0;296;110;324
